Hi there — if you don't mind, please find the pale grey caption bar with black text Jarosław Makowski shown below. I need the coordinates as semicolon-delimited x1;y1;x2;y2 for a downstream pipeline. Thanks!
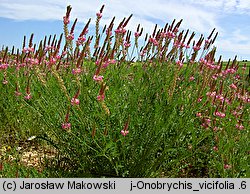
0;178;250;194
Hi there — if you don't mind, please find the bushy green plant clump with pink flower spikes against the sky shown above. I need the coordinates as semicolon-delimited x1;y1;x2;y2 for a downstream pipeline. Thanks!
0;5;250;178
